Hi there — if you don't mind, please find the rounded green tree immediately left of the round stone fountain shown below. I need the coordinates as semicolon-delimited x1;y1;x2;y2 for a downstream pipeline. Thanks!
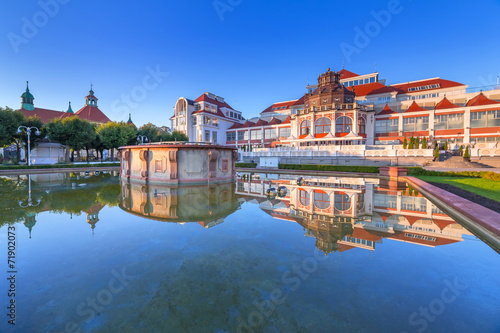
97;121;137;160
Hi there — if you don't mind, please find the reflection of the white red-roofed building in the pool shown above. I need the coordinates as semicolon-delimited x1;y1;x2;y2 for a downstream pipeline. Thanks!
236;174;471;254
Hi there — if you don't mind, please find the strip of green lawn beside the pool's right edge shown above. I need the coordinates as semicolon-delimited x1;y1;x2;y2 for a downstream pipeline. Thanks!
417;176;500;202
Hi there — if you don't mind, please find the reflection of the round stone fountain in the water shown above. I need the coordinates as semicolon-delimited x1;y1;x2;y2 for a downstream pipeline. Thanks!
120;181;239;228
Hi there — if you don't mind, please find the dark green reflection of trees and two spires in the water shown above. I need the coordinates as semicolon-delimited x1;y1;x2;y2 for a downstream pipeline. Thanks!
0;171;120;238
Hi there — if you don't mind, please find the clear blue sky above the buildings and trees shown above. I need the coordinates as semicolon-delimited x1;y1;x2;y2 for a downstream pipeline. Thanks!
0;0;500;126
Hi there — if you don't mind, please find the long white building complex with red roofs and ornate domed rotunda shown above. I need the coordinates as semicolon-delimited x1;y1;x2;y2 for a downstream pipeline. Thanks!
172;69;500;161
